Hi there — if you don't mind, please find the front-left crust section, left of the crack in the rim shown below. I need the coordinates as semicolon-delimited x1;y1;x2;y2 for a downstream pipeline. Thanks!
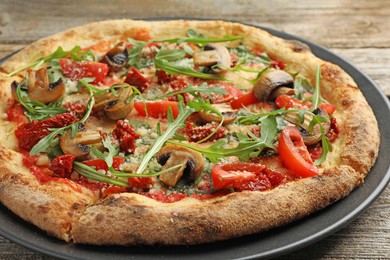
0;147;96;241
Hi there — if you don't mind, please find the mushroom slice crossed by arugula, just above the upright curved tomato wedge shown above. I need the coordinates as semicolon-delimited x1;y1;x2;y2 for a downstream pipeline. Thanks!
284;108;330;145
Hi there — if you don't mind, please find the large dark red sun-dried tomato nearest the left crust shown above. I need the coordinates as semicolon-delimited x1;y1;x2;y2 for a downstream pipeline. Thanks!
15;113;76;151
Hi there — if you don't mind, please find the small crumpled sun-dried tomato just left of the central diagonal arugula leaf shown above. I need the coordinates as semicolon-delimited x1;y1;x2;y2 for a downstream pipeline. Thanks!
112;120;140;153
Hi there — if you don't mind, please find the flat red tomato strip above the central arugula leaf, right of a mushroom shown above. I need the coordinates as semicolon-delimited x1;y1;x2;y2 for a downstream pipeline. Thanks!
134;101;179;118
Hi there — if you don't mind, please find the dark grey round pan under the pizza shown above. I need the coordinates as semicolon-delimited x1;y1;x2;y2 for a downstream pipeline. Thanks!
0;18;390;260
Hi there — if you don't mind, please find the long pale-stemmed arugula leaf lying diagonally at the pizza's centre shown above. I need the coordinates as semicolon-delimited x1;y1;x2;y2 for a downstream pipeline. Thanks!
136;102;194;174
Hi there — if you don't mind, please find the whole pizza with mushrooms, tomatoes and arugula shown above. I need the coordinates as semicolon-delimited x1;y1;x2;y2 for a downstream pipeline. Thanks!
0;20;380;245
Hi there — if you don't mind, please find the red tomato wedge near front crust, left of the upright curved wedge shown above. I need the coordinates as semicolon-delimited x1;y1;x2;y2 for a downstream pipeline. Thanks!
211;162;265;189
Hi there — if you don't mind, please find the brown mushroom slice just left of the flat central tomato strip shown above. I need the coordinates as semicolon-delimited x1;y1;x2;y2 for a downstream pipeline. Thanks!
93;86;134;120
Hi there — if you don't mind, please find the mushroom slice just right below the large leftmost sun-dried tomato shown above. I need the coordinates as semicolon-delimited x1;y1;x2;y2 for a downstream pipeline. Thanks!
60;131;102;160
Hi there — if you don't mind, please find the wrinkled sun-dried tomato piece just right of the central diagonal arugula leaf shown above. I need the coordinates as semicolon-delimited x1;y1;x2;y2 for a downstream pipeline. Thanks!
185;121;228;142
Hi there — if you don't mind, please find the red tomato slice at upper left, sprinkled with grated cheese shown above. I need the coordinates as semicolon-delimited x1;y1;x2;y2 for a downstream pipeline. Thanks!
59;59;109;84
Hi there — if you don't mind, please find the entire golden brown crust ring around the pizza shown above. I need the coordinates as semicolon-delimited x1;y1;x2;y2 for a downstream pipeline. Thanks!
0;20;379;245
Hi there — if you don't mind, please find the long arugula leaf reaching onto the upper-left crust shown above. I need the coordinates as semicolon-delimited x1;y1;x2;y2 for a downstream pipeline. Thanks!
8;46;93;77
